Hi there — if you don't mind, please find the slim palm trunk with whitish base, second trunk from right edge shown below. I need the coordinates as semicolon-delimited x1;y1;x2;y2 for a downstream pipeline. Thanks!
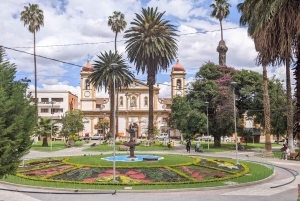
286;59;295;152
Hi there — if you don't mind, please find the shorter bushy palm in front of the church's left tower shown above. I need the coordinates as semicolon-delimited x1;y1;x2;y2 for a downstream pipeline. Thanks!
89;51;134;133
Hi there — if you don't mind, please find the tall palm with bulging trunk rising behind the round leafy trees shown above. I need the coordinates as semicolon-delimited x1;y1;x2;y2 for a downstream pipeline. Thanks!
210;0;231;66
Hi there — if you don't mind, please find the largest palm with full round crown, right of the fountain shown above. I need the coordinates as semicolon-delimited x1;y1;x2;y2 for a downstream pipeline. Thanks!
124;7;178;140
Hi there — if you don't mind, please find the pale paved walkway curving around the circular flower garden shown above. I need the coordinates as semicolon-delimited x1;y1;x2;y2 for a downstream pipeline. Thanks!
0;144;300;201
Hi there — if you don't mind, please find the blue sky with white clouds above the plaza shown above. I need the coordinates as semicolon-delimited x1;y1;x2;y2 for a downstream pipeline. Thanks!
0;0;294;99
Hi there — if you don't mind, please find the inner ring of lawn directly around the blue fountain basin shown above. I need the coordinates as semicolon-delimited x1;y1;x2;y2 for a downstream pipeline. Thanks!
68;153;195;167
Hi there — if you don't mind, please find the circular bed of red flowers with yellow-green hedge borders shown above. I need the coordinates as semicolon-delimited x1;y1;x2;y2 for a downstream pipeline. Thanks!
17;155;249;185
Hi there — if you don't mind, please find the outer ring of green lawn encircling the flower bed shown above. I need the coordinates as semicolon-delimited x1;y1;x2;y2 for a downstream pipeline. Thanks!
2;155;273;190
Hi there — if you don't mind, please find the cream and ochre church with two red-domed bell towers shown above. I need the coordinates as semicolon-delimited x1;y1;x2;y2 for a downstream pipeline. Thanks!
80;60;186;138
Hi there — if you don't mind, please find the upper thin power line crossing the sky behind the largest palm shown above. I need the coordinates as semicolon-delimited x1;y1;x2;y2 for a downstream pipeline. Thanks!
6;27;244;48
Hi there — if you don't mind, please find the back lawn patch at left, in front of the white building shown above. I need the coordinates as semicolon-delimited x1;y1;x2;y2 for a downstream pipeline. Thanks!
31;141;85;152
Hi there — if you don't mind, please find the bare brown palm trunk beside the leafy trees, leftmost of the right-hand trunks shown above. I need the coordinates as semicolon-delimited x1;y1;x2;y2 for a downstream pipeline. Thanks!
263;65;272;156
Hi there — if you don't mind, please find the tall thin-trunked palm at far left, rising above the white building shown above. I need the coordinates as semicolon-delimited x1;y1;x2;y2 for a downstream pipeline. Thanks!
20;3;44;108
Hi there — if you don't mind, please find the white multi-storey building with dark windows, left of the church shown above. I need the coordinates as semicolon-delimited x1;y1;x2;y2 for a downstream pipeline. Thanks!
29;90;78;122
